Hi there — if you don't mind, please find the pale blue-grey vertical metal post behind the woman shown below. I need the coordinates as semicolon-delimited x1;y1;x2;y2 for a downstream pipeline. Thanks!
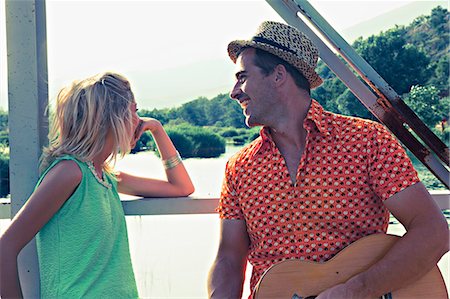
5;0;48;298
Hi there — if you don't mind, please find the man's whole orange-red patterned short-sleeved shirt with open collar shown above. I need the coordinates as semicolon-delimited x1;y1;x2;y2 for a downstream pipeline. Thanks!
218;100;419;296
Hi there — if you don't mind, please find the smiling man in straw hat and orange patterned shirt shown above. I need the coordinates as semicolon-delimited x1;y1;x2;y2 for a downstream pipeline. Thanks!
208;22;449;299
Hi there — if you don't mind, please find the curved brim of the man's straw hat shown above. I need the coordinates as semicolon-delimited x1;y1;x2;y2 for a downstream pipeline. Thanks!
228;40;323;89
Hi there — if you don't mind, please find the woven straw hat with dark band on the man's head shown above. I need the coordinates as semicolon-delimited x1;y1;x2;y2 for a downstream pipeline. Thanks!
228;21;322;89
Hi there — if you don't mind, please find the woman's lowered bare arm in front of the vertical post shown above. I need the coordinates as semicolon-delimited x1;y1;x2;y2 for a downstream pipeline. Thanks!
0;161;82;298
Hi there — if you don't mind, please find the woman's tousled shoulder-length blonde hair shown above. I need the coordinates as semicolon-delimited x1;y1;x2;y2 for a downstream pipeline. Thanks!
40;72;135;171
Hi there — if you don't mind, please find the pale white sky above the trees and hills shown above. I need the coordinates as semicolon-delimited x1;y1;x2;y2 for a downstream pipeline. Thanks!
0;0;448;109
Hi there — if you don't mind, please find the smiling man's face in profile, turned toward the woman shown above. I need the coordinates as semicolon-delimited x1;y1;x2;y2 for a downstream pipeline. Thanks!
230;48;276;127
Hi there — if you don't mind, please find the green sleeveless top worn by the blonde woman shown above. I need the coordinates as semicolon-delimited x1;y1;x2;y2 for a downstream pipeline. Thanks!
36;156;138;298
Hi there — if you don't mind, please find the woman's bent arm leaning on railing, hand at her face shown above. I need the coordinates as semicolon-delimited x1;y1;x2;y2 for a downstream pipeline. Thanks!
117;118;194;197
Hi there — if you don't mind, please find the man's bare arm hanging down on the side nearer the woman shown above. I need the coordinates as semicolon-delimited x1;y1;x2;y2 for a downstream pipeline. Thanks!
208;219;250;299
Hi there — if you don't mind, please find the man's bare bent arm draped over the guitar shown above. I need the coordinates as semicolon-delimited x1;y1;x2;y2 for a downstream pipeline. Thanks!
317;183;449;299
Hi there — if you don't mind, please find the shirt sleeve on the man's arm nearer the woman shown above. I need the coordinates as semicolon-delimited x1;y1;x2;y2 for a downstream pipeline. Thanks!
217;161;244;219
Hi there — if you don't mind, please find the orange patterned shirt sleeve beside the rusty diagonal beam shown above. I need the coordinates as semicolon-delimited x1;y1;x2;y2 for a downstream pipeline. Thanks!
368;124;420;201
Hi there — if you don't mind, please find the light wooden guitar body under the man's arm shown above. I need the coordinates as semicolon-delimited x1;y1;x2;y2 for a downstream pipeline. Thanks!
254;234;448;299
